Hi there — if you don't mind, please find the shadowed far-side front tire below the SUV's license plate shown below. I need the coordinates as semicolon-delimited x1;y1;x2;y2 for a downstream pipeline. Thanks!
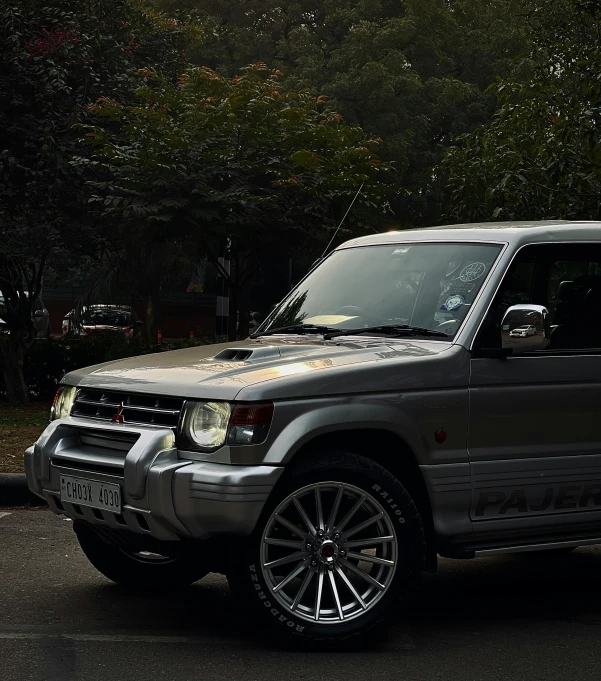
76;528;209;591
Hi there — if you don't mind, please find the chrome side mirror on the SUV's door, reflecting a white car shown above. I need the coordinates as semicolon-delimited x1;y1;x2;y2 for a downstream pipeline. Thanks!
501;305;549;355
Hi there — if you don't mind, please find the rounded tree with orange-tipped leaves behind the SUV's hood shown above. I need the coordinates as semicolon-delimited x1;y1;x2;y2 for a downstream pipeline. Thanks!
75;63;394;338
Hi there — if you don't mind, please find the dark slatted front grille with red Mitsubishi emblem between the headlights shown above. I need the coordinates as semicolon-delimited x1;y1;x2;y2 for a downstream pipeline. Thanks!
71;388;184;430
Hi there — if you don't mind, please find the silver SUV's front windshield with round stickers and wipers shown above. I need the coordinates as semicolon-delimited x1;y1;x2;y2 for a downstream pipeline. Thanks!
261;243;501;337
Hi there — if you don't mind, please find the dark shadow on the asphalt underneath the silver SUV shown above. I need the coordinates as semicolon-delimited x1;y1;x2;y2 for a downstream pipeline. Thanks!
71;546;601;651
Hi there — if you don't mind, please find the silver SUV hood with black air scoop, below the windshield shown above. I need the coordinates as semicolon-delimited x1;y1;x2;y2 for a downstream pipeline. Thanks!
63;336;456;400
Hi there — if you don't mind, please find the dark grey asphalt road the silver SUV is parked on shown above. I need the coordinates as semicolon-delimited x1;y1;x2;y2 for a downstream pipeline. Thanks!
0;509;601;681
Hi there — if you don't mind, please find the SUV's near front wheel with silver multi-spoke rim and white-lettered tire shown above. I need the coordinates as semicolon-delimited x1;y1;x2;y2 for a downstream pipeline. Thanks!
227;451;426;649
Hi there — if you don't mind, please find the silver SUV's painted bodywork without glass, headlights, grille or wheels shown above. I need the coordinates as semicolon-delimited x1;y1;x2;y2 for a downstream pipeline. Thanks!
26;222;601;555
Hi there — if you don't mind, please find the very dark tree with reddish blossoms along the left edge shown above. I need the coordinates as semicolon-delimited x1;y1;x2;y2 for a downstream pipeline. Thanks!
0;0;200;401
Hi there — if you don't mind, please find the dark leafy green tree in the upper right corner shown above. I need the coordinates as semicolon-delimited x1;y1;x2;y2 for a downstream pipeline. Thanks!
440;0;601;220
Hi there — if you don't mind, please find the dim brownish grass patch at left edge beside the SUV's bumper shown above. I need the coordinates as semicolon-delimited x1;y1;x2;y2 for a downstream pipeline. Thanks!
0;402;50;473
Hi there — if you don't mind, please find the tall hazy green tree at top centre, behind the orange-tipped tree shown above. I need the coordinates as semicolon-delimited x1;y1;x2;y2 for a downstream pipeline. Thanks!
155;0;528;226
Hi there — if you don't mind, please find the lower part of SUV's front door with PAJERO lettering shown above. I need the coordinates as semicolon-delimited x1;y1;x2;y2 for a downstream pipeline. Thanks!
469;352;601;534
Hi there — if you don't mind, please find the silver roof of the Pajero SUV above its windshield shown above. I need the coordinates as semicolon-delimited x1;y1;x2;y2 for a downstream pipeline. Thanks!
338;220;601;248
